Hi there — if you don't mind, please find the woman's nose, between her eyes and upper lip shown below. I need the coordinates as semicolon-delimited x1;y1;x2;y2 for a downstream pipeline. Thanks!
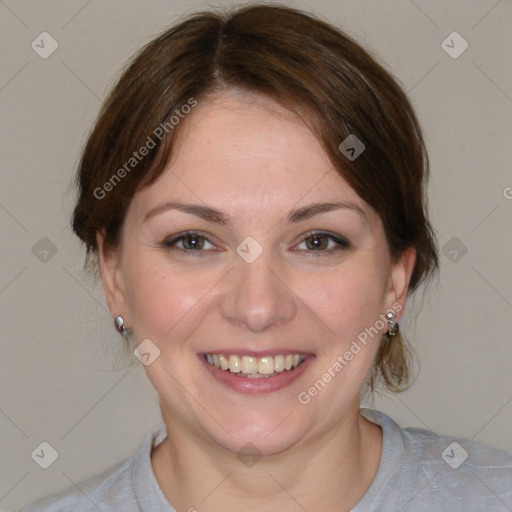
221;251;297;333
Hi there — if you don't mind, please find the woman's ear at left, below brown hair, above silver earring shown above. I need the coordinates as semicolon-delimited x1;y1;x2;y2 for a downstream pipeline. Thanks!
96;231;131;326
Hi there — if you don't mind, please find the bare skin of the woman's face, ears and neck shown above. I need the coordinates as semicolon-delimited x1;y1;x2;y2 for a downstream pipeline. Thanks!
98;91;415;512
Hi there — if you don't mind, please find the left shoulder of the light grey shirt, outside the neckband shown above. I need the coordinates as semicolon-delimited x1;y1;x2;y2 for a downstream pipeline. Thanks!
19;458;135;512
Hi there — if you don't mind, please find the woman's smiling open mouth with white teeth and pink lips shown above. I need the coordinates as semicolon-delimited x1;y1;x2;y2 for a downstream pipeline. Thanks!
198;351;315;394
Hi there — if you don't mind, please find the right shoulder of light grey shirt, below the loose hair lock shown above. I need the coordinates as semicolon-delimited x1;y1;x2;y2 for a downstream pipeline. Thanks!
365;409;512;511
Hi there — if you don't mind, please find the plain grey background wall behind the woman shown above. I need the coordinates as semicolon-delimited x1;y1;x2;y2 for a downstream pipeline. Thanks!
0;0;512;510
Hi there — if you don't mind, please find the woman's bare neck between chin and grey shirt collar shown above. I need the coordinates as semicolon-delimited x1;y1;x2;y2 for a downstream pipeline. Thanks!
152;406;382;512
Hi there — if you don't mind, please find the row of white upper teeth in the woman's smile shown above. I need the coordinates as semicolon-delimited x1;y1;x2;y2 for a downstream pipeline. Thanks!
206;354;306;375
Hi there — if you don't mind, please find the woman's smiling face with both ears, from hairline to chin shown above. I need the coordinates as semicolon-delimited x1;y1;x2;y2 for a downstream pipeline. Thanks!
98;92;413;453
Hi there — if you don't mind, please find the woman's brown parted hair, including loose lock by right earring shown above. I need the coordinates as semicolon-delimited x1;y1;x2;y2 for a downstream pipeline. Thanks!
73;4;439;391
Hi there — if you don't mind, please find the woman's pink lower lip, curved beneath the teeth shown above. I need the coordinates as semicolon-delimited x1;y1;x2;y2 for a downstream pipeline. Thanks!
199;355;314;394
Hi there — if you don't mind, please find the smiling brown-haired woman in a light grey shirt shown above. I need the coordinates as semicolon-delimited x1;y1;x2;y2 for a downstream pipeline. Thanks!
18;5;512;512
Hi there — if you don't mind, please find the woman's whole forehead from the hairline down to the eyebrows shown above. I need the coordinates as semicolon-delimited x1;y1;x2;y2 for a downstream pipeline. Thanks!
130;91;374;227
